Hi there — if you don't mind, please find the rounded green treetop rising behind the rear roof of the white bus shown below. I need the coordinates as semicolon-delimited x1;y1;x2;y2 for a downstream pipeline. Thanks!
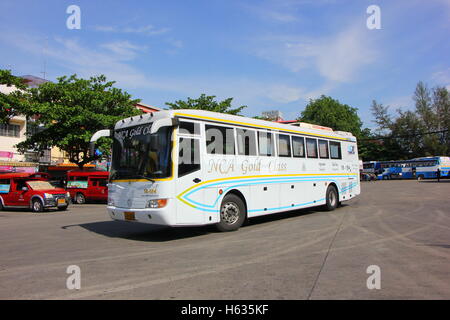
298;95;362;137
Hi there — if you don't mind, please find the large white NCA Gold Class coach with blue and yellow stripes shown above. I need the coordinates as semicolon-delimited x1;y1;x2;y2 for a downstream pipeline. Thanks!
91;110;360;231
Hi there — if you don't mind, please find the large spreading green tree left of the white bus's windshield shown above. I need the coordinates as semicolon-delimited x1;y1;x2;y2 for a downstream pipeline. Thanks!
17;75;141;169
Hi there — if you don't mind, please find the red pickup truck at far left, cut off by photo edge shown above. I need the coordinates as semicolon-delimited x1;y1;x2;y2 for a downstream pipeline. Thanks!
0;172;70;212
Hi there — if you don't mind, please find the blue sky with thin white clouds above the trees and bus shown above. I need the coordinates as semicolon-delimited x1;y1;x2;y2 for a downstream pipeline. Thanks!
0;0;450;127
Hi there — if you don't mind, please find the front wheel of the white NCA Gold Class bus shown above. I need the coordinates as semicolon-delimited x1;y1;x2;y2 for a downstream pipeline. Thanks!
216;194;246;232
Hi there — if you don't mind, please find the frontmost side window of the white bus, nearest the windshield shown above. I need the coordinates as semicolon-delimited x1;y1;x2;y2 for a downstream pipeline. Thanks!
178;138;200;177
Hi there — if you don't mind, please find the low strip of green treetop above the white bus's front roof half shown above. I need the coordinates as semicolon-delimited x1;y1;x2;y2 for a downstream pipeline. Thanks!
166;94;247;115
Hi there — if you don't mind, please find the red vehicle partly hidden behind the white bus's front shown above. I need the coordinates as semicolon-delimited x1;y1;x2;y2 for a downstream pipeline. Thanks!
66;170;109;204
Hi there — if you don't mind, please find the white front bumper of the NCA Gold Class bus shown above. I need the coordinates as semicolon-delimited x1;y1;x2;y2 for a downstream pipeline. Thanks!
107;206;175;226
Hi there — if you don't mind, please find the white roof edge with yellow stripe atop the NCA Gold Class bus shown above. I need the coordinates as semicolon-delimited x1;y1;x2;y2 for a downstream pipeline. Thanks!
114;109;356;142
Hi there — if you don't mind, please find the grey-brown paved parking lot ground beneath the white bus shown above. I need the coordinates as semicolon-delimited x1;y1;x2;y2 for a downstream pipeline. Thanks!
0;180;450;299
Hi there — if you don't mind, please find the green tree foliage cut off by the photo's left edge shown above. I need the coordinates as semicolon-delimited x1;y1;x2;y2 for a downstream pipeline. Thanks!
0;70;27;123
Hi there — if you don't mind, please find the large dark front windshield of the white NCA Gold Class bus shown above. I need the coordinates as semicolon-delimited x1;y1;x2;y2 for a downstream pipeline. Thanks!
110;123;172;180
